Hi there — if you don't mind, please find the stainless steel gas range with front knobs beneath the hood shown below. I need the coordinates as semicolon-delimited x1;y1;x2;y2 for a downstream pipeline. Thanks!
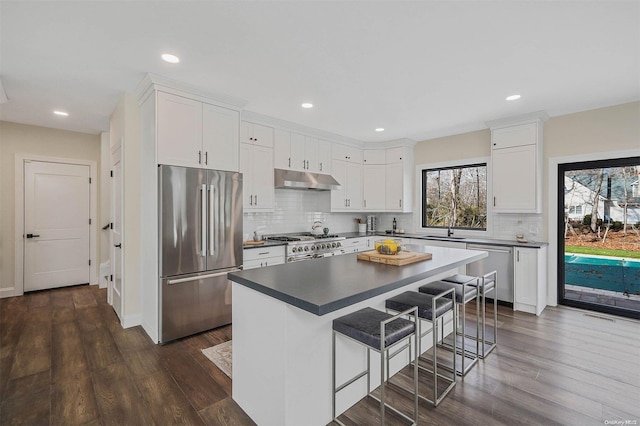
265;233;345;263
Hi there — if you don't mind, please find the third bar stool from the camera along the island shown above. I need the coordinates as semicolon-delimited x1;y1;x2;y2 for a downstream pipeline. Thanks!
418;278;480;376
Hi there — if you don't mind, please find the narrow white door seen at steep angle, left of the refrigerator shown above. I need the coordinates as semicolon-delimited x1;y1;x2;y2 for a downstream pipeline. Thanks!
107;147;123;319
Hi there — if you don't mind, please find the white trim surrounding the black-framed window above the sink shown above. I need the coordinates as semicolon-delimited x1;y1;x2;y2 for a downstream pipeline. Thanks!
414;157;493;238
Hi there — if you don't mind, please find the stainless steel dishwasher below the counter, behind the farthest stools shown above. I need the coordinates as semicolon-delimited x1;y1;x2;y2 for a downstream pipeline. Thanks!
467;244;513;304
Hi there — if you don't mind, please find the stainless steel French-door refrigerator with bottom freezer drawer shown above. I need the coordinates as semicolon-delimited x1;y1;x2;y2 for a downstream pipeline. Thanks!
158;165;242;343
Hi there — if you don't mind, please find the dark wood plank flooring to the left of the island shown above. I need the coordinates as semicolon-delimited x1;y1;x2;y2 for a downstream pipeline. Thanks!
0;286;254;426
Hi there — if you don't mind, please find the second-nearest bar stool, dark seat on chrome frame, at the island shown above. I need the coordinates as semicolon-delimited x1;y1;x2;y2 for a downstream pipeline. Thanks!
385;289;456;407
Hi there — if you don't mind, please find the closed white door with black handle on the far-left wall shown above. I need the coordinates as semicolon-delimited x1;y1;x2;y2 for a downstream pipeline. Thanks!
24;161;91;291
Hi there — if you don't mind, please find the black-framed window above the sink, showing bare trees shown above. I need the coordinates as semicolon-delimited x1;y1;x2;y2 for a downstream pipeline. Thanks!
422;163;487;231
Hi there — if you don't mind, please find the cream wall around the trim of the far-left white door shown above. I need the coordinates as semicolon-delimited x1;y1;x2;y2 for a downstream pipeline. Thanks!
0;121;102;290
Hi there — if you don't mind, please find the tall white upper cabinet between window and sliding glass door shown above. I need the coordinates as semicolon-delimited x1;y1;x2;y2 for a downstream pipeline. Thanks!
490;114;546;213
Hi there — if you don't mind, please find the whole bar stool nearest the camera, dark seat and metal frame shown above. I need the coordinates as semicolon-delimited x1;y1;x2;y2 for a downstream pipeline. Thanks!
331;306;418;426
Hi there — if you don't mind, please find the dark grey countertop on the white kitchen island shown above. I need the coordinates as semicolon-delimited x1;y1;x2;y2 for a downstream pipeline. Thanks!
228;246;487;315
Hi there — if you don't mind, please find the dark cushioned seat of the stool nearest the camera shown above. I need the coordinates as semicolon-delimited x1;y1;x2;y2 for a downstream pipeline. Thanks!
333;305;415;350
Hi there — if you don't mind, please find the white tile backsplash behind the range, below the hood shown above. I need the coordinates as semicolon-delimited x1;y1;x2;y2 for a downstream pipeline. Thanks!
243;189;413;239
